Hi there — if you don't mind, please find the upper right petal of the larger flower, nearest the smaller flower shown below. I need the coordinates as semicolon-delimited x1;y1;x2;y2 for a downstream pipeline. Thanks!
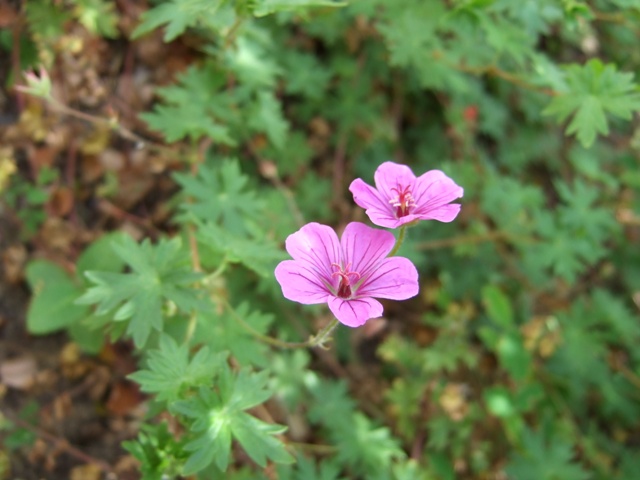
340;222;396;278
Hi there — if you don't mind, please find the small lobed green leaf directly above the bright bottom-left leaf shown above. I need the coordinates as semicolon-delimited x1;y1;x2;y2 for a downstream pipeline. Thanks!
129;335;226;403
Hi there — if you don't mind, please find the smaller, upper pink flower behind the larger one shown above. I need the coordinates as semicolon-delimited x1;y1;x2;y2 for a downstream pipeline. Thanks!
349;162;464;228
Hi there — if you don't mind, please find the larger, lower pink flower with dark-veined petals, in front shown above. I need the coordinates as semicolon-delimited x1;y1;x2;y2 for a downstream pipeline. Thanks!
275;222;418;327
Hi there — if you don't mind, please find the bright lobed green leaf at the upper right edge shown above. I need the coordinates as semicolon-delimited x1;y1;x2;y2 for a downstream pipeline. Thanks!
543;59;640;147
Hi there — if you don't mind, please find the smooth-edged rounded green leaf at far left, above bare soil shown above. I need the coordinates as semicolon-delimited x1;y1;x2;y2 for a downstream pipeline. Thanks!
26;260;90;335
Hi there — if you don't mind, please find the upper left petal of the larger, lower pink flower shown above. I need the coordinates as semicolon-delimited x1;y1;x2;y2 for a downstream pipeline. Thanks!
286;222;340;284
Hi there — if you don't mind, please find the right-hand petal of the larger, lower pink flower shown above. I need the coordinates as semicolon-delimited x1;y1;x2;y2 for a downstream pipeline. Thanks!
356;257;419;300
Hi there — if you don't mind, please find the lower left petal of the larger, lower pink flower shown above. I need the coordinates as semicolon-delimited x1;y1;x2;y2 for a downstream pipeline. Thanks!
275;260;330;305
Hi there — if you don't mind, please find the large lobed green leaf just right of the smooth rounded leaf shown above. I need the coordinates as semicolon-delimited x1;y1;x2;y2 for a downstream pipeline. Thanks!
76;236;206;347
